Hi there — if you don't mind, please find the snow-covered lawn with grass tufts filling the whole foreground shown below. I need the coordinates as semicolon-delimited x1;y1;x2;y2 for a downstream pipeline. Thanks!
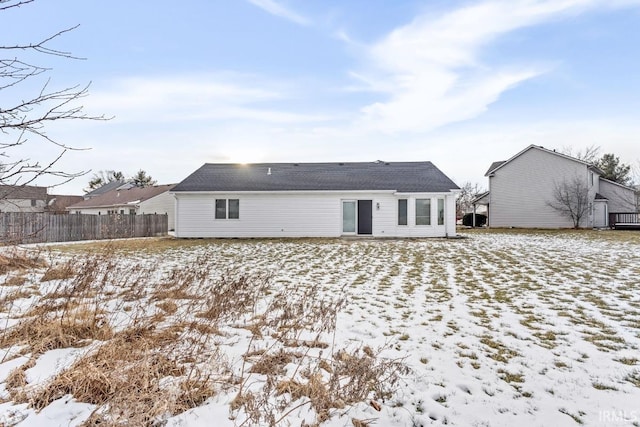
0;231;640;427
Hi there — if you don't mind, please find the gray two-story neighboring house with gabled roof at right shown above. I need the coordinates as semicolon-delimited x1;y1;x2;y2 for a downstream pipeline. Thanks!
474;145;637;228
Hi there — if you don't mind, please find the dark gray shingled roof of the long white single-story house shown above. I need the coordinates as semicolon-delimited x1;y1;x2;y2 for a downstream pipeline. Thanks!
172;161;459;193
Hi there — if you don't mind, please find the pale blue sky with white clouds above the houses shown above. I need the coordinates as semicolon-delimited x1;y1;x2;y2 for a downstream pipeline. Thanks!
0;0;640;194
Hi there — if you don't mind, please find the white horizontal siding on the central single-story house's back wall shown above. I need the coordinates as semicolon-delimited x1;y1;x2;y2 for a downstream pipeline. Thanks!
174;192;455;237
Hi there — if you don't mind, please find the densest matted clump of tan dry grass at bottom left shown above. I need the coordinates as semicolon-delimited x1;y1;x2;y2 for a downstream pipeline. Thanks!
30;323;224;426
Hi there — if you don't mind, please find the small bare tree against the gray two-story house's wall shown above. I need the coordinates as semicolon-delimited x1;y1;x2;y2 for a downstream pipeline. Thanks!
547;176;590;228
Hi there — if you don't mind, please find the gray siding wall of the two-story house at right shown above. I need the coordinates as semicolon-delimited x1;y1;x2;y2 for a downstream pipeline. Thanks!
489;146;599;228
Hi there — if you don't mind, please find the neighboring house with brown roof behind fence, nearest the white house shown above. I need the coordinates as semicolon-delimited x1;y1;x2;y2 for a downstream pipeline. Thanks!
67;184;175;230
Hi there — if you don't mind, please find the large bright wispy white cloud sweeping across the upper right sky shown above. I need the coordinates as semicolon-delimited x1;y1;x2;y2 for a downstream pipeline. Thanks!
352;0;638;133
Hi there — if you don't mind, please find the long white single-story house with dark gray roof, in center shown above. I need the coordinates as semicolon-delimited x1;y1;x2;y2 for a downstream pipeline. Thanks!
172;161;459;238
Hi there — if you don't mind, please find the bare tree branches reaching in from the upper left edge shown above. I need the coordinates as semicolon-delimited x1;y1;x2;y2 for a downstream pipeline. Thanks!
0;0;106;185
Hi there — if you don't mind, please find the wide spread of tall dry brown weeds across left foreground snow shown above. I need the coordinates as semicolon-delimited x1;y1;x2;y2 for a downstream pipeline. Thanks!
0;249;404;426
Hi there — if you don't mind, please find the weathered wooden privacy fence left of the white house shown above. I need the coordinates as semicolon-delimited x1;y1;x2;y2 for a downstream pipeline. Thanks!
0;212;168;244
